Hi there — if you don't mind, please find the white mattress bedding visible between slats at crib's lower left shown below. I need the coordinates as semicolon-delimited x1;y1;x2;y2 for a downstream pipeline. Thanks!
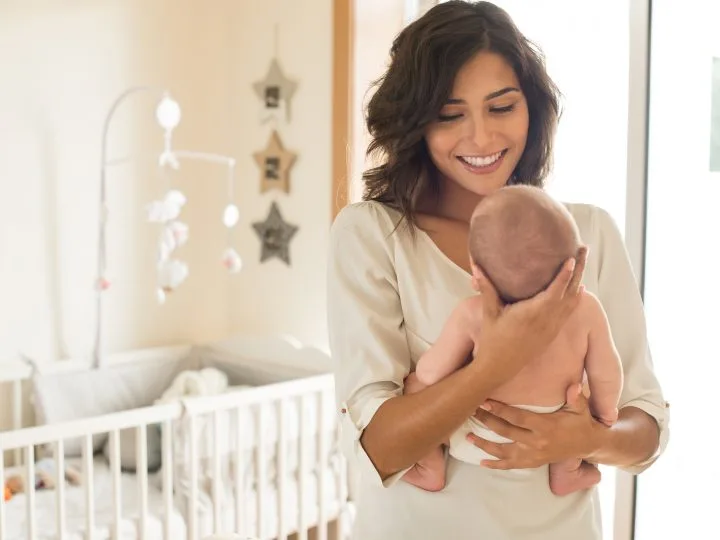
3;457;186;540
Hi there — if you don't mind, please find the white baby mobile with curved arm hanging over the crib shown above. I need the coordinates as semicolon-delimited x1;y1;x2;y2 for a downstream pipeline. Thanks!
94;86;242;367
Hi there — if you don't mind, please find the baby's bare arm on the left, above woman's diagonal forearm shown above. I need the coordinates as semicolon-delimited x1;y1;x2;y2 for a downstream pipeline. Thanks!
415;297;480;386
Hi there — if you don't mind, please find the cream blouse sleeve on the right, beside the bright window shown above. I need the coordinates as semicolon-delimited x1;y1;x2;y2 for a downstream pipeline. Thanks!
594;208;669;474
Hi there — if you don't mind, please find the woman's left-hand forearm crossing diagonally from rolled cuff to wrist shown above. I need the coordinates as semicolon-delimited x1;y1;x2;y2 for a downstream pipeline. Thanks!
360;361;500;479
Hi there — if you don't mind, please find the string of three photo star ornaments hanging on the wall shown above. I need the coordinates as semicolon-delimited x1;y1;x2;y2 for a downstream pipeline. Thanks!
252;3;298;266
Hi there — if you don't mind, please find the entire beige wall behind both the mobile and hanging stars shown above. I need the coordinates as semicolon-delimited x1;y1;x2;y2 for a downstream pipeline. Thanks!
0;0;332;372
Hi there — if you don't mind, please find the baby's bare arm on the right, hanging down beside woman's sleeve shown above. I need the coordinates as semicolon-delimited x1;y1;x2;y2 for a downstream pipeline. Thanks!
585;293;623;425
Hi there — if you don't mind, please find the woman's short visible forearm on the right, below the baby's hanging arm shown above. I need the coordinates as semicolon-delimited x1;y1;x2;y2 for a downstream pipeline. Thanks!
586;407;660;467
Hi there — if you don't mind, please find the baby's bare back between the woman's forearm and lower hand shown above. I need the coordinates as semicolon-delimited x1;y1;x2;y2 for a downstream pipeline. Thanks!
490;295;593;407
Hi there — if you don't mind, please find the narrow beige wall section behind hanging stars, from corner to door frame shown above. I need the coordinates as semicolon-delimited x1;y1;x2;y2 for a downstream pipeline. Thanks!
226;0;333;347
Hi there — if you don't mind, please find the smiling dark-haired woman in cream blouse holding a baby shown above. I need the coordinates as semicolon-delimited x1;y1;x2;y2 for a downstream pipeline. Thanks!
328;1;668;540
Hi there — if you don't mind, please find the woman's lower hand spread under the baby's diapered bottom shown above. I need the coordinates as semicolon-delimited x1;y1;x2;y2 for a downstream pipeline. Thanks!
468;385;608;470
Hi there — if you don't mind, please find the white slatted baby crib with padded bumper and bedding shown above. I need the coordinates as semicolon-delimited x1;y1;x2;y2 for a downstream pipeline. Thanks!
0;338;351;540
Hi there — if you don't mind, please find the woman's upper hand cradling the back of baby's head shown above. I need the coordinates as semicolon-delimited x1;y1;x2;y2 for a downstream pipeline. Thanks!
472;246;588;384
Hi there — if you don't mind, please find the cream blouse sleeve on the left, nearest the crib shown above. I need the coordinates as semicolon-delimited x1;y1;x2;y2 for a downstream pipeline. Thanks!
327;202;411;486
